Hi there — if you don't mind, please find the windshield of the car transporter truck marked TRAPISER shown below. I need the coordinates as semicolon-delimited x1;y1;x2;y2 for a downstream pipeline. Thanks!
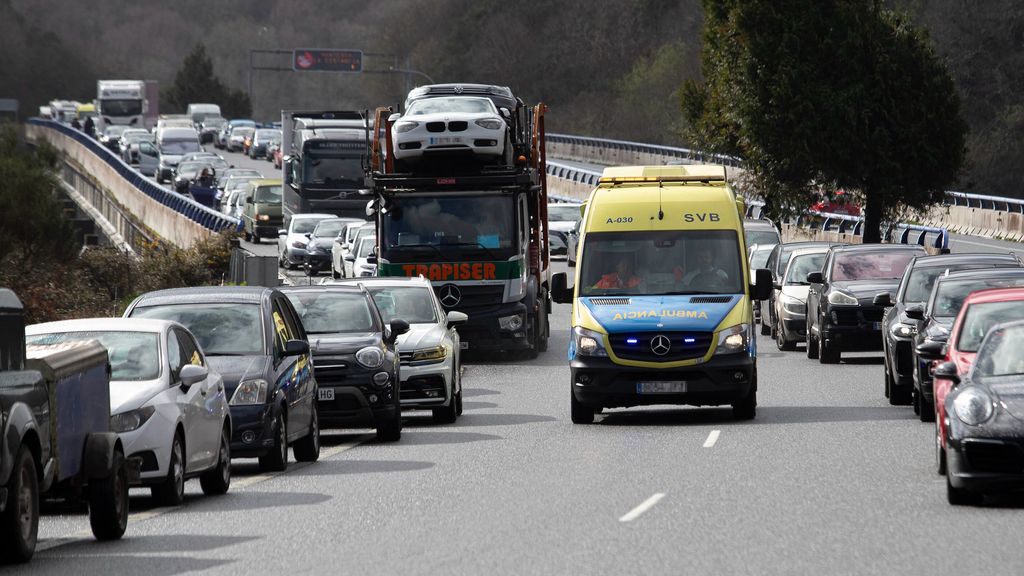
383;195;516;259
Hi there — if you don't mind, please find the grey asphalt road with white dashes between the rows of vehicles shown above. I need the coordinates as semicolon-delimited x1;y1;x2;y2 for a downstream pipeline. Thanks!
22;146;1024;576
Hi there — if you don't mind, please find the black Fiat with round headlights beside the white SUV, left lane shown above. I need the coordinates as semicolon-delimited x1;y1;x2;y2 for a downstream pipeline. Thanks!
282;285;409;442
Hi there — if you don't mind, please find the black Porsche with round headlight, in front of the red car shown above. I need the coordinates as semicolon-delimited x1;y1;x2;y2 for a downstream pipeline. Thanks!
935;321;1024;504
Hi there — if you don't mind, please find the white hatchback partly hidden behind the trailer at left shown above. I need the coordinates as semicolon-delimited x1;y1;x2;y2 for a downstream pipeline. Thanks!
25;318;231;505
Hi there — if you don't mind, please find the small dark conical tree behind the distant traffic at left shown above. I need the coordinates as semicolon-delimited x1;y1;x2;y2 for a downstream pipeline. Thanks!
160;43;253;118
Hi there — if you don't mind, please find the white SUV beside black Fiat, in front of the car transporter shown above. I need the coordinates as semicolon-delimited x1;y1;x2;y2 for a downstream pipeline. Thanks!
331;278;469;423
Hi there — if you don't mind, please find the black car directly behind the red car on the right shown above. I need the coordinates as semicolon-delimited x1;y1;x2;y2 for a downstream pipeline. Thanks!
905;268;1024;422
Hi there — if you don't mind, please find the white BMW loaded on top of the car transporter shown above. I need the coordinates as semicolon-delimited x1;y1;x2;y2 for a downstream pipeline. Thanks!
391;96;508;160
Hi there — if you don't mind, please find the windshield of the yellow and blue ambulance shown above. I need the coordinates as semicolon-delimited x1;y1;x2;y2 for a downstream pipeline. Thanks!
580;230;743;296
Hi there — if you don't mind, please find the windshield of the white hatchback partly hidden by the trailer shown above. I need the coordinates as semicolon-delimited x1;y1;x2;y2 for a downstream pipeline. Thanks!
25;330;161;381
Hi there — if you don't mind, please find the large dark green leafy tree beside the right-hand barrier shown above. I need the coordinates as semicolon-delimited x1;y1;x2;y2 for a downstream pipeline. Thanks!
682;0;967;243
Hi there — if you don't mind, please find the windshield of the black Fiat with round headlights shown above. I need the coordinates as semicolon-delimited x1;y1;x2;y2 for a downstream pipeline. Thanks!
288;290;379;334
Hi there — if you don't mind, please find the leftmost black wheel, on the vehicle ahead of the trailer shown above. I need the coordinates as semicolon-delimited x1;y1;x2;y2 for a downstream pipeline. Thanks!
0;446;39;564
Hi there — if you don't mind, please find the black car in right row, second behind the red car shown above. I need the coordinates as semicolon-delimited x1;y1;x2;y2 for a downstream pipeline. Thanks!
876;254;1021;406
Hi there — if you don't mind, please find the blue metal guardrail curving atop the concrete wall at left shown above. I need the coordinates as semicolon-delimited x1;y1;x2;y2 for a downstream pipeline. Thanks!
27;118;239;232
